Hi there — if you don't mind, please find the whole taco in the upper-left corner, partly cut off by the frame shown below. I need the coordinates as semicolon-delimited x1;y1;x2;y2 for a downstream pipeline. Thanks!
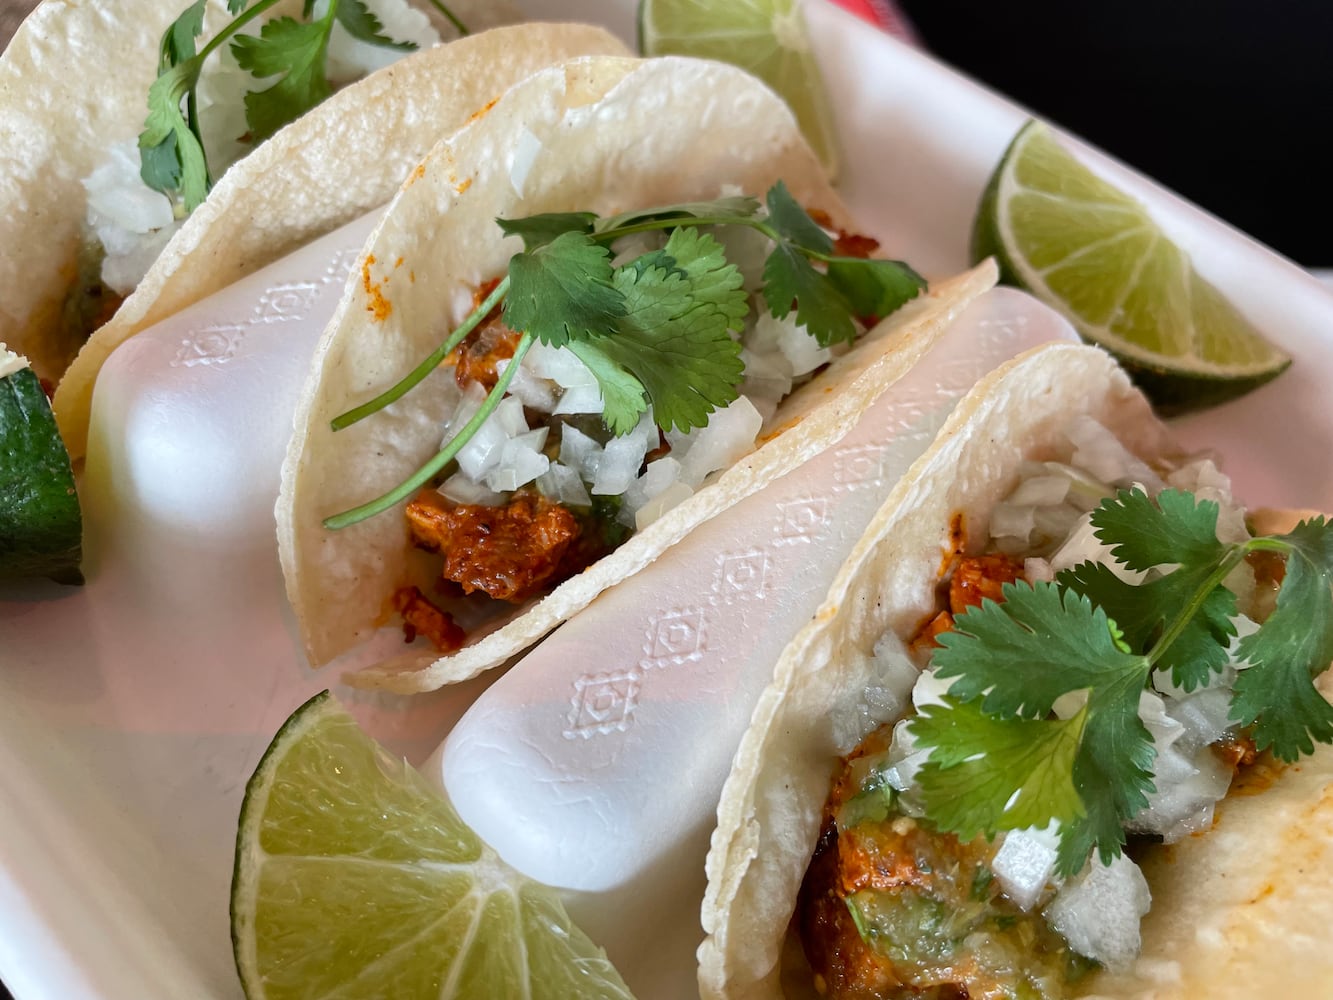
0;0;625;459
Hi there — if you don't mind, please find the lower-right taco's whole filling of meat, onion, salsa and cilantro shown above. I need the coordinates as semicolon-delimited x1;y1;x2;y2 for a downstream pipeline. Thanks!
793;417;1333;1000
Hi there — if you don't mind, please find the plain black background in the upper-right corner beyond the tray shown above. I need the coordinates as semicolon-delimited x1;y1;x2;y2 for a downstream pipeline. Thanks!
898;0;1333;268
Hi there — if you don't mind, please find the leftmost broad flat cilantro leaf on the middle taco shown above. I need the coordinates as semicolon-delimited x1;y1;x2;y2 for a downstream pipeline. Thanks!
504;232;625;347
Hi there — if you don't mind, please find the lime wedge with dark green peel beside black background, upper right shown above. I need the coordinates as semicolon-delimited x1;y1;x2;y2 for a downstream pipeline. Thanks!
972;121;1292;412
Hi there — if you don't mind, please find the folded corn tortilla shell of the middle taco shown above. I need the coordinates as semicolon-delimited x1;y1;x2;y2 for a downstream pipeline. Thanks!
277;51;994;692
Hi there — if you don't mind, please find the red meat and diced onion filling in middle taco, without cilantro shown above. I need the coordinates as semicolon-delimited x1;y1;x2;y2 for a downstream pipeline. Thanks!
395;218;878;652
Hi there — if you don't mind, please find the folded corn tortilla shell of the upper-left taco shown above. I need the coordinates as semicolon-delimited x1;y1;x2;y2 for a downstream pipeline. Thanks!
0;0;627;459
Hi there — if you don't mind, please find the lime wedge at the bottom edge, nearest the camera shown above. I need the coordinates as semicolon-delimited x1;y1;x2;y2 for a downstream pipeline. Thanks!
232;692;631;1000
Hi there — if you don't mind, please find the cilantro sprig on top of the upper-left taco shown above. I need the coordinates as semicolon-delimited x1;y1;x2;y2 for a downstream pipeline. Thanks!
139;0;467;212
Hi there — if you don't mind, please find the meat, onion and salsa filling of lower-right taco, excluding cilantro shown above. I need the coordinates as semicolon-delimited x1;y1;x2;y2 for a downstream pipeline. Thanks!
796;420;1265;1000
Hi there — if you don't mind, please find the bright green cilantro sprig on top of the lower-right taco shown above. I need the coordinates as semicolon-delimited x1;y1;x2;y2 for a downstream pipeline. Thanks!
909;489;1333;876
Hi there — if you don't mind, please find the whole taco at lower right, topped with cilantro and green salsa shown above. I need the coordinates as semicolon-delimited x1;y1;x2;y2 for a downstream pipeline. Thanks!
698;345;1333;997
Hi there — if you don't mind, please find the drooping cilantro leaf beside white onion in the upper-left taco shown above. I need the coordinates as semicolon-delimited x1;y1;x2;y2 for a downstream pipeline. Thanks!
139;60;208;211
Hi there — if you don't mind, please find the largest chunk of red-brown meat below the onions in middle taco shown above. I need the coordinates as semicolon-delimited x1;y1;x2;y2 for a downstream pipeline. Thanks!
407;491;583;601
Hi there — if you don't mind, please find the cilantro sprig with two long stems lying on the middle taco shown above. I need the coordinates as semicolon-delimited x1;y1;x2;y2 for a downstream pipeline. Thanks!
324;181;926;529
